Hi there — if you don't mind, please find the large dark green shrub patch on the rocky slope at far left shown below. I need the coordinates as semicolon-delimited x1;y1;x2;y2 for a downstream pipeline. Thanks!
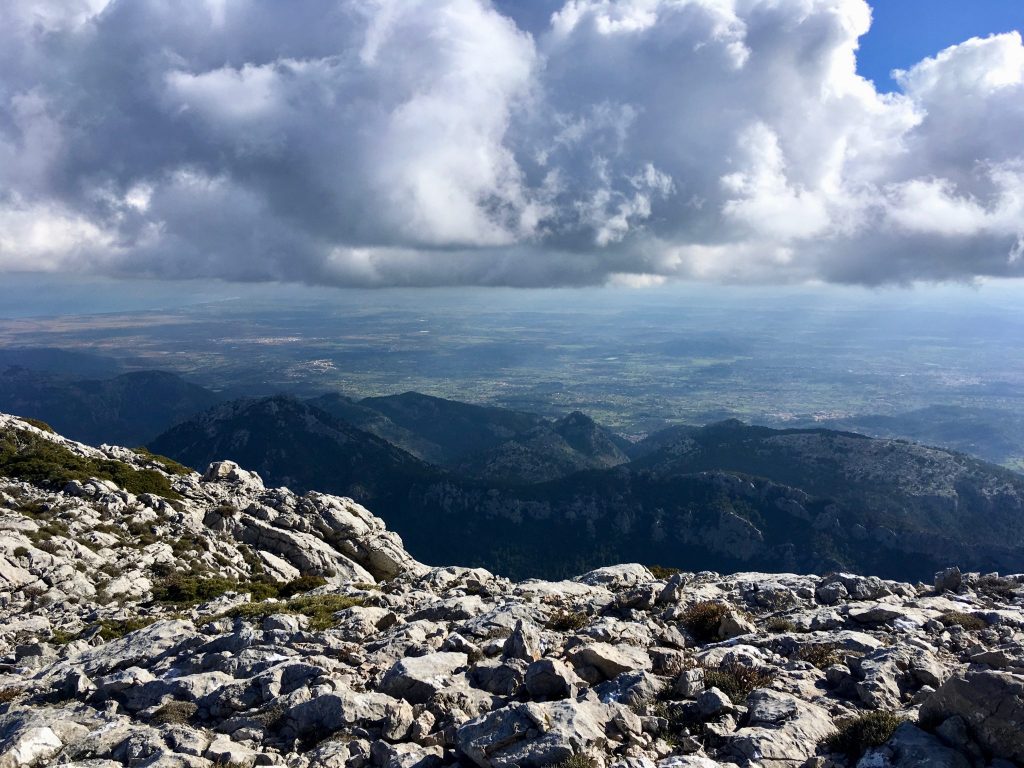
0;429;181;499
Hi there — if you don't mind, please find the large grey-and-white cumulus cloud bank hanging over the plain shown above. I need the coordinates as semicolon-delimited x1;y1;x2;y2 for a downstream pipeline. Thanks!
0;0;1024;286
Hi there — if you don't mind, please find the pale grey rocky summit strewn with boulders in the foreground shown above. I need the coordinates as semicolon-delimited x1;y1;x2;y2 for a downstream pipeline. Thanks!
0;415;1024;768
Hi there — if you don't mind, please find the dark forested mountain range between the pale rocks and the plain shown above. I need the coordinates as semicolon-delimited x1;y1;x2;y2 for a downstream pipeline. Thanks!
6;358;1024;579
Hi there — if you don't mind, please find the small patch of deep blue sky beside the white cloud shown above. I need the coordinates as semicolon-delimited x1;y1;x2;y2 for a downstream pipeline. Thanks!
857;0;1024;91
